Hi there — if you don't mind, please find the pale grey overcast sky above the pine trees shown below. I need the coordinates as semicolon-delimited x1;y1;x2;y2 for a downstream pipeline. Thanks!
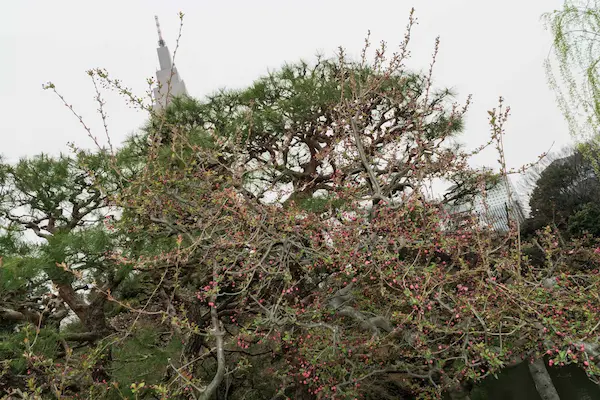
0;0;570;167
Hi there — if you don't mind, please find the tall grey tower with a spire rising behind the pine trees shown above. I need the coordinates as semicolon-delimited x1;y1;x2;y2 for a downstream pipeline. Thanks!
154;16;187;110
